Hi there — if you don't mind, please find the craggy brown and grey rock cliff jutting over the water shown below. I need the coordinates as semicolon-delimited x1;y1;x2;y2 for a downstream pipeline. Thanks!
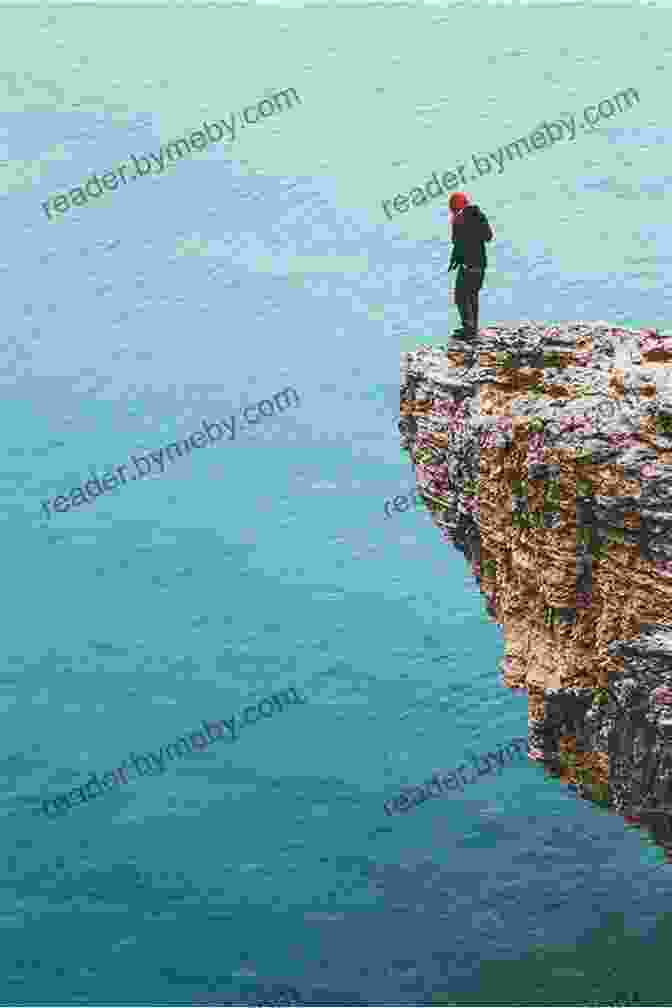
399;323;672;856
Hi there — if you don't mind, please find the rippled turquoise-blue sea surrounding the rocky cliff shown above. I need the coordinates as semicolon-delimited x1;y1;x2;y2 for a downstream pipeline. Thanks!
0;5;671;1005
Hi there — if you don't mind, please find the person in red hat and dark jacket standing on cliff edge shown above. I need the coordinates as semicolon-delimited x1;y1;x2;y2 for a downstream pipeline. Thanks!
448;193;493;342
